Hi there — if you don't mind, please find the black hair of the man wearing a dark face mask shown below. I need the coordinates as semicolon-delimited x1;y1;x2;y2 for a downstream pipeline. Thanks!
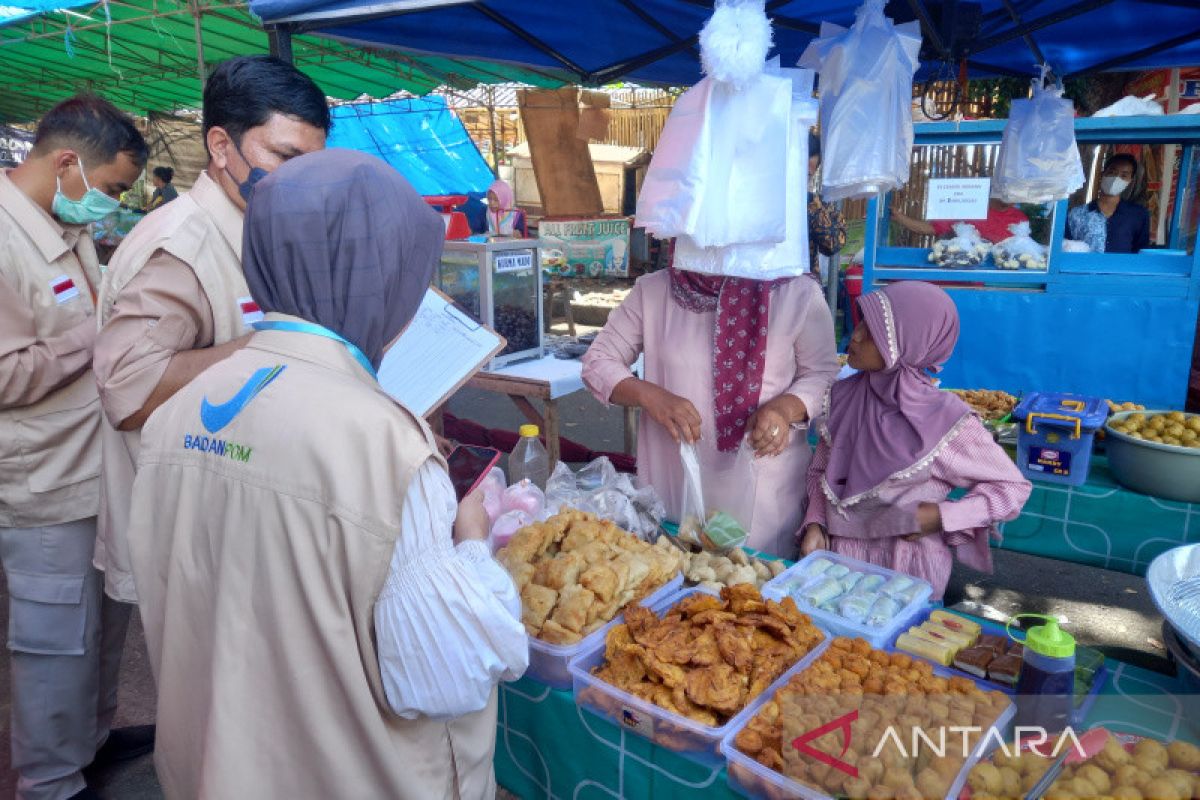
204;55;332;144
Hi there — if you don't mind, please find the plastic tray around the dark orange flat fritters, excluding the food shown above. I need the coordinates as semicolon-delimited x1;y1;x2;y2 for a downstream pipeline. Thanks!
570;587;829;765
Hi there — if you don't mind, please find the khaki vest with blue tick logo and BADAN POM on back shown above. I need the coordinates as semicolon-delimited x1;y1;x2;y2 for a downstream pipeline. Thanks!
130;314;496;800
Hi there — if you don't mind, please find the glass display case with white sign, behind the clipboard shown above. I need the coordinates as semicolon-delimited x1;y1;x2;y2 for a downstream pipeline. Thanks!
437;239;542;369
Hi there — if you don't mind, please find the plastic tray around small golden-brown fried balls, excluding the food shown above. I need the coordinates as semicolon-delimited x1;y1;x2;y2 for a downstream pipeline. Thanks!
721;648;1016;800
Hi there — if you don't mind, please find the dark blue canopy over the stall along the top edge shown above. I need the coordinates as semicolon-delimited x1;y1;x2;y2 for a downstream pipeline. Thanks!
250;0;1200;85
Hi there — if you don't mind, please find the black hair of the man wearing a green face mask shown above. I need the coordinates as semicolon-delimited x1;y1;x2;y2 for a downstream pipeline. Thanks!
32;94;150;169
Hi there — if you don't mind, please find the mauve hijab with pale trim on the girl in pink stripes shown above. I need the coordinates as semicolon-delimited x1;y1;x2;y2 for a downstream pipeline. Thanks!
822;281;971;505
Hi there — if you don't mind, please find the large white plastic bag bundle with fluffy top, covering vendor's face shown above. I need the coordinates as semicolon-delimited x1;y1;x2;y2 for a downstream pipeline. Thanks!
637;0;817;281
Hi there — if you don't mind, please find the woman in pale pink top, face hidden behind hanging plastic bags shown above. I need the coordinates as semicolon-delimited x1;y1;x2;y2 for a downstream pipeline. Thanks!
583;266;838;557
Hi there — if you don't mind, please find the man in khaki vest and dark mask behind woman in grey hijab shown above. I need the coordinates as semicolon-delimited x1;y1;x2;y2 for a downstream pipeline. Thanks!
94;56;330;603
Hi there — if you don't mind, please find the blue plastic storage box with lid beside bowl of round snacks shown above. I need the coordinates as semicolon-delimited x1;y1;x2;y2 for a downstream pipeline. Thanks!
1013;392;1109;486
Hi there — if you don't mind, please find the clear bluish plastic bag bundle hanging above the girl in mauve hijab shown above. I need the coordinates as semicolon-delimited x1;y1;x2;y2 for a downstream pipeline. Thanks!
800;0;920;201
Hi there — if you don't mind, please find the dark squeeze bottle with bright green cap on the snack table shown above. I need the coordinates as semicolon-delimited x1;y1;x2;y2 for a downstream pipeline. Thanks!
1008;614;1075;733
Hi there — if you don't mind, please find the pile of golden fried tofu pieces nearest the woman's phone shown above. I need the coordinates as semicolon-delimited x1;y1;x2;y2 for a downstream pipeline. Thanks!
496;509;683;644
